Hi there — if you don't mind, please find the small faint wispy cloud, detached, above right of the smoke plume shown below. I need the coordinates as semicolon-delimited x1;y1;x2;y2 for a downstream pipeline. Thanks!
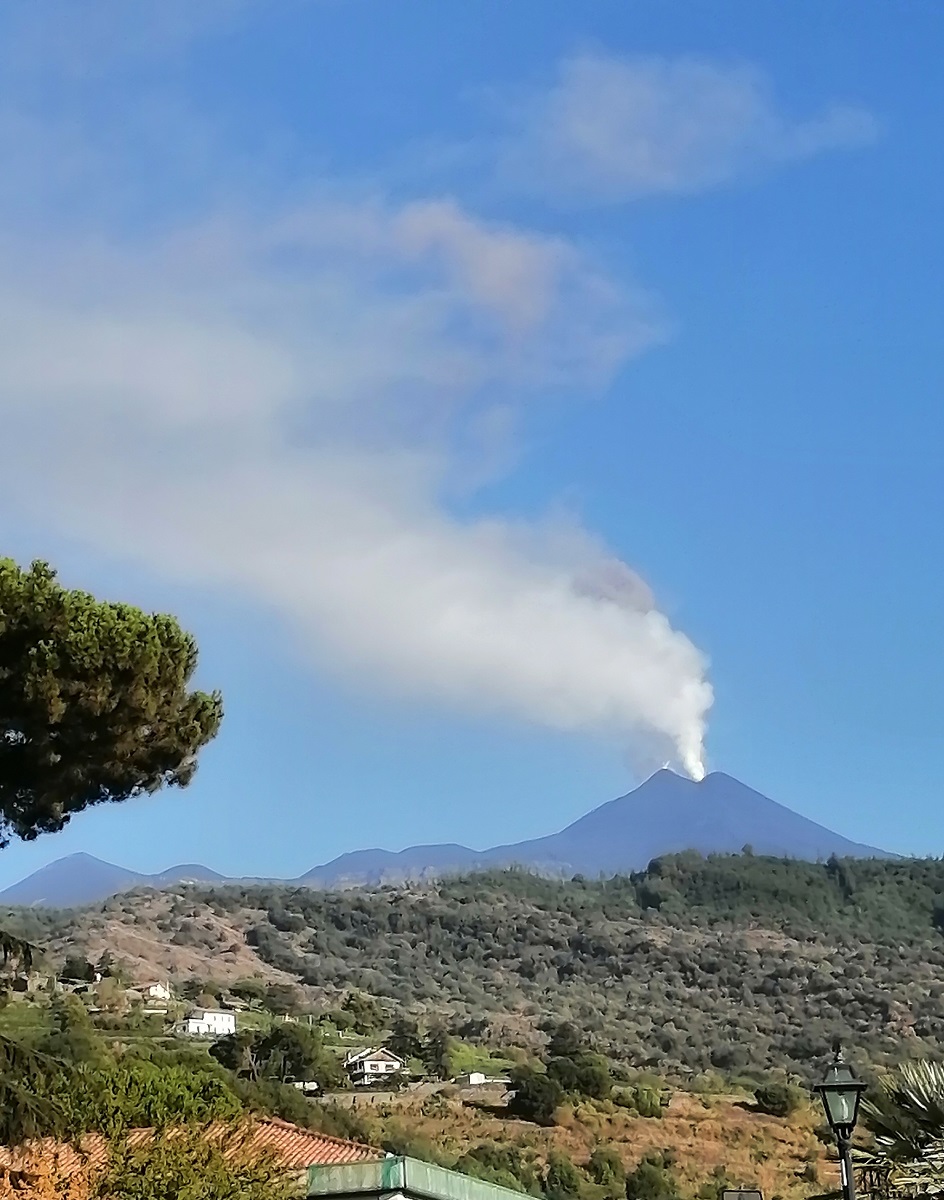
498;53;879;204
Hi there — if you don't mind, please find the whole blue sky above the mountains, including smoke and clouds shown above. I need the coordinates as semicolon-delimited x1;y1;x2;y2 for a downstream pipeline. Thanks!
0;0;944;884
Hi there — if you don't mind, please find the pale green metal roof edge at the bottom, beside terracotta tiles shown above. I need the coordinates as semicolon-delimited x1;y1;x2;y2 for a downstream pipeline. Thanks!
307;1157;522;1200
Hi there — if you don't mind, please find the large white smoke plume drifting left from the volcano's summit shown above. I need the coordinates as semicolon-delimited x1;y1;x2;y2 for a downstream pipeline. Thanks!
0;200;711;779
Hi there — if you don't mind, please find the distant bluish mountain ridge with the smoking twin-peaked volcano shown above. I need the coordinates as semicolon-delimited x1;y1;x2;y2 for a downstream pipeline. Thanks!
0;770;894;908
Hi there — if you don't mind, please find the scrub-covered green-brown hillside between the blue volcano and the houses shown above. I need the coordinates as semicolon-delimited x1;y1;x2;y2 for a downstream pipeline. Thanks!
7;854;944;1078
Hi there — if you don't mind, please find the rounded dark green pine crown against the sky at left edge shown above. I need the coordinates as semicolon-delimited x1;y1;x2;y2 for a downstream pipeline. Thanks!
0;558;222;846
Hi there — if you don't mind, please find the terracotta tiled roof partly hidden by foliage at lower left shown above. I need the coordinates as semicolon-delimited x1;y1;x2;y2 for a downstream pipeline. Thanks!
0;1117;384;1175
